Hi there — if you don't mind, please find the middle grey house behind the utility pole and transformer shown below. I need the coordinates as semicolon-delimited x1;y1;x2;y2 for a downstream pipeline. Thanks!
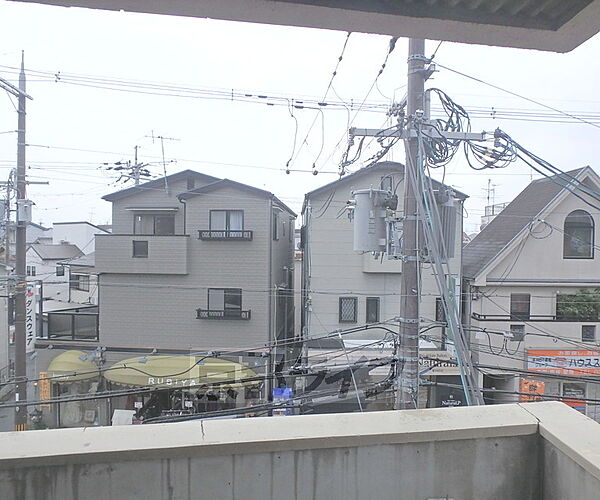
301;161;466;408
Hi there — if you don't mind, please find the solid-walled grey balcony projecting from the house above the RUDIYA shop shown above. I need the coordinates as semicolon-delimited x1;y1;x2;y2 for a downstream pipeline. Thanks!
95;234;189;275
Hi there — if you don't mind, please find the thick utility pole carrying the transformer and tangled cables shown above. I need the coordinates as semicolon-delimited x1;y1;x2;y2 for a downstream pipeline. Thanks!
396;38;426;410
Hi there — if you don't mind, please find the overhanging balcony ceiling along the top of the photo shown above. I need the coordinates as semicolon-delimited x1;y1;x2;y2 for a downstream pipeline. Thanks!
8;0;600;52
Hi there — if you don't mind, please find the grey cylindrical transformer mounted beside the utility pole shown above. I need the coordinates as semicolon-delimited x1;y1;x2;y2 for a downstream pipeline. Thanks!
352;189;390;252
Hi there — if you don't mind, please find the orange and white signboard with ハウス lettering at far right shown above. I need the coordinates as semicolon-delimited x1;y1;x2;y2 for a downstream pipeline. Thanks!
527;350;600;375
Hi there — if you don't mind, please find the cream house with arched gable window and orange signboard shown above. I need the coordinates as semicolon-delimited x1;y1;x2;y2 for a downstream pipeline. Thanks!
463;167;600;420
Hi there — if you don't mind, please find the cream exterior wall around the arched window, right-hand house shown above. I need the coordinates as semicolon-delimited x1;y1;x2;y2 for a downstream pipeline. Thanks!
469;184;600;421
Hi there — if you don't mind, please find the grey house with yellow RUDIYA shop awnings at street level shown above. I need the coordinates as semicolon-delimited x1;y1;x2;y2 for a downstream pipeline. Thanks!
31;170;296;426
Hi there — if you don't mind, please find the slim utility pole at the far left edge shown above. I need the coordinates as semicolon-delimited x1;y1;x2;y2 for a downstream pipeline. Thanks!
15;55;27;431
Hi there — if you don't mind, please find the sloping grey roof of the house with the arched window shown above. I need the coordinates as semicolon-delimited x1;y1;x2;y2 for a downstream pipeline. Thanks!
463;167;595;278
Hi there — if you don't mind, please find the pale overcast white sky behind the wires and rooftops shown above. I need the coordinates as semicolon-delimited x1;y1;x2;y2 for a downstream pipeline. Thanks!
0;0;600;232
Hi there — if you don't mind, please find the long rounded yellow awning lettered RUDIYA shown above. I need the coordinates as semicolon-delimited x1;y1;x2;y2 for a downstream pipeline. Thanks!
104;356;260;389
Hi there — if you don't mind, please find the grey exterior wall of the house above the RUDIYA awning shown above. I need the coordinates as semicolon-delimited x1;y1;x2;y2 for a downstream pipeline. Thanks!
96;183;292;350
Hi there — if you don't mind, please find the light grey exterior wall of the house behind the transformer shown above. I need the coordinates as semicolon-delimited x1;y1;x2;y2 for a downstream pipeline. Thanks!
303;169;462;339
